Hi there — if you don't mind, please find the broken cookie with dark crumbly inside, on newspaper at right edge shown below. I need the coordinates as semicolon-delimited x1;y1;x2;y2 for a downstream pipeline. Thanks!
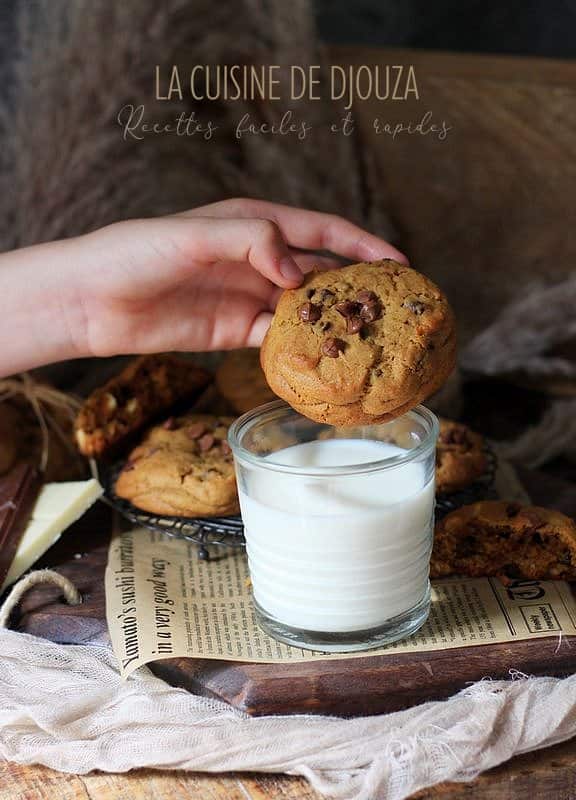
430;500;576;580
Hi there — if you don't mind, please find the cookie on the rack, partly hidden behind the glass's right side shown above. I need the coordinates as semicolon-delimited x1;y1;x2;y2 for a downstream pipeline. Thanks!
436;419;486;494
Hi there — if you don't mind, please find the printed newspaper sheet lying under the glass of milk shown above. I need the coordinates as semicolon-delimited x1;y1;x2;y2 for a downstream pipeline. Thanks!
106;528;576;677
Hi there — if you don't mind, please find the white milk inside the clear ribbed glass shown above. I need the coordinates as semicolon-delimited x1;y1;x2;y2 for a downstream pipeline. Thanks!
240;439;434;633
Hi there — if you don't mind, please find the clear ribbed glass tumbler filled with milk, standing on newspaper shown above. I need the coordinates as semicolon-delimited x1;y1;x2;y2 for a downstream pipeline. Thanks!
229;401;438;652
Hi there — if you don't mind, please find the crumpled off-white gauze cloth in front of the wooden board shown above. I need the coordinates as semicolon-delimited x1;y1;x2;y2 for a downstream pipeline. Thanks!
0;630;576;800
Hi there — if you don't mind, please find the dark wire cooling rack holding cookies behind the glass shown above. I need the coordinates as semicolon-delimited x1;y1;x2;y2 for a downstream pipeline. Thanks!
97;445;497;561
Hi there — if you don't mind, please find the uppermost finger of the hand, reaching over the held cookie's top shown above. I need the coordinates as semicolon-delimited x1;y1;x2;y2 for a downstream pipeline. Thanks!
178;199;408;264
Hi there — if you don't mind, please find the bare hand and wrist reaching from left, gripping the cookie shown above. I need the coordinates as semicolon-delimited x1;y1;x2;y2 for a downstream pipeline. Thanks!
0;200;406;374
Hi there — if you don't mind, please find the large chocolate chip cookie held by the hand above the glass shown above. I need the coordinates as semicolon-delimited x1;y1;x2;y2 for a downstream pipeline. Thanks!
261;260;456;426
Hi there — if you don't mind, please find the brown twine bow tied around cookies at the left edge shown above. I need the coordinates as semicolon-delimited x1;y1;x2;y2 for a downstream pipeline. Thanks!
0;372;80;471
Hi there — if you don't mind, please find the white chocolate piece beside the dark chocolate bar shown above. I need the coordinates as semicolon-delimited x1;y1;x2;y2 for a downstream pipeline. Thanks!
2;478;104;590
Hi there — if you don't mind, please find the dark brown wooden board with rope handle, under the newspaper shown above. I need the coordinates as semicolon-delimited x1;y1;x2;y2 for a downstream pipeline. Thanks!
11;468;576;716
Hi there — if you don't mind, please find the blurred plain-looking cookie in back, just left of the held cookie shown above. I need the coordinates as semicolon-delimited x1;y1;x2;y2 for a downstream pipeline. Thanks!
216;347;277;414
